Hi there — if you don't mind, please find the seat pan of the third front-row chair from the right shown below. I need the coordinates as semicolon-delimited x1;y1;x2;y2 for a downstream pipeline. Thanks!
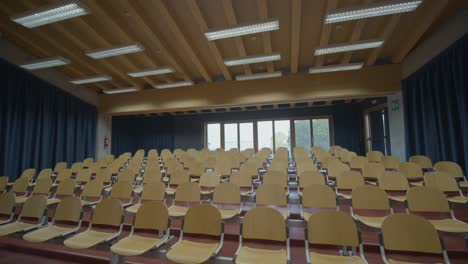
236;246;287;264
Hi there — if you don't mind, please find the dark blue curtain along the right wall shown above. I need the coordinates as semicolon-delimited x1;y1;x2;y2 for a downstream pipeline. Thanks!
402;35;468;172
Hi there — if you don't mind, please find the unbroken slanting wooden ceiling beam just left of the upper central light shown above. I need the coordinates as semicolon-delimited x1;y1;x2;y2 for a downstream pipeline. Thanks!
152;1;213;82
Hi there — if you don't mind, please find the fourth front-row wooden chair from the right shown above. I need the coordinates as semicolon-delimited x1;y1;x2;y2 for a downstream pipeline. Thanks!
166;204;224;263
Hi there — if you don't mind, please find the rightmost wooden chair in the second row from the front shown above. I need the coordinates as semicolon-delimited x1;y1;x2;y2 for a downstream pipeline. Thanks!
407;186;468;233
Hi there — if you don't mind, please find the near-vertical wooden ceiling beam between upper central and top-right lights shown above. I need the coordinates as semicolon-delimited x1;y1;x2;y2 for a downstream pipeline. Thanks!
291;0;302;73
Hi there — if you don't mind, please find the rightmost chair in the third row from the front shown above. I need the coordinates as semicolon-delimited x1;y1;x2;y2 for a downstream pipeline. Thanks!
424;171;468;204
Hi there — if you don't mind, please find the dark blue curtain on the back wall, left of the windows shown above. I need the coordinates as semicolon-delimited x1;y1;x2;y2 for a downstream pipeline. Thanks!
111;116;174;155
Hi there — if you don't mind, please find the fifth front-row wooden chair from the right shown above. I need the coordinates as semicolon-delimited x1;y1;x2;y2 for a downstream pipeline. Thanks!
111;202;170;256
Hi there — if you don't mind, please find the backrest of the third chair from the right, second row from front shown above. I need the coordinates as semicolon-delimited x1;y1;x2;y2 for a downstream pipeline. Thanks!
302;184;336;208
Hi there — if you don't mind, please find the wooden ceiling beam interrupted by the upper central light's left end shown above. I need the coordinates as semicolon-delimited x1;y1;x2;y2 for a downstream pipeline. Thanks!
185;0;232;80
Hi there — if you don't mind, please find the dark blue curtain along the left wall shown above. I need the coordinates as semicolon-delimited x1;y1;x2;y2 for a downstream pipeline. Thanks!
0;60;97;180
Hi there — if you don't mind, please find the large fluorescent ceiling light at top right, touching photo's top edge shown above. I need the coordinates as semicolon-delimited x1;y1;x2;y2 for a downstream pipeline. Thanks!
325;0;422;24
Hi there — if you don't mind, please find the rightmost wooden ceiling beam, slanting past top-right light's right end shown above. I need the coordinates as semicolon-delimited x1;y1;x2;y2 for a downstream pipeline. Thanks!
392;0;449;63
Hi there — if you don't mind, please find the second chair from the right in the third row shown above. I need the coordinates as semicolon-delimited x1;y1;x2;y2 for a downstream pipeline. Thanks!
378;171;409;202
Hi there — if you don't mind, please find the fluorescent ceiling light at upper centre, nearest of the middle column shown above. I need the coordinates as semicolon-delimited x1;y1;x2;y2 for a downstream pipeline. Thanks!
205;20;279;40
